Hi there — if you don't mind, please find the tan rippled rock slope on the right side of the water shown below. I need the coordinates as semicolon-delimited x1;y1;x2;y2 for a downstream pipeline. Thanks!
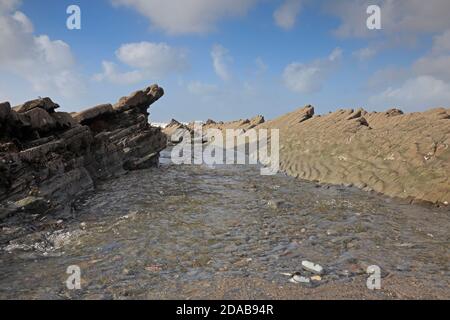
258;106;450;204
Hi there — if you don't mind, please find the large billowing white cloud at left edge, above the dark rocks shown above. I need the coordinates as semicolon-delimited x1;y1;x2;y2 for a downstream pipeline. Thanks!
0;0;83;97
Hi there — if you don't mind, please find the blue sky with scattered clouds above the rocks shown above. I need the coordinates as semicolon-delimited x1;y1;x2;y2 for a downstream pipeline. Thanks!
0;0;450;122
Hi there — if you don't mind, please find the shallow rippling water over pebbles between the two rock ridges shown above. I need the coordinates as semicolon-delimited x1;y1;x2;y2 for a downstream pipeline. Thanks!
0;152;450;299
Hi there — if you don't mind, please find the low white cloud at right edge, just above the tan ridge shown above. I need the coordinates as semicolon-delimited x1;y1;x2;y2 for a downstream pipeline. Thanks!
369;76;450;111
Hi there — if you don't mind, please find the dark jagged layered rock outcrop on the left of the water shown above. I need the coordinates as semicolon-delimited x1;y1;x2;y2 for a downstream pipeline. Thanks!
0;85;166;218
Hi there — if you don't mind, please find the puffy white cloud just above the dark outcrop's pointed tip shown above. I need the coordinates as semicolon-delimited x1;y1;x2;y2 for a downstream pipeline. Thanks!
94;42;189;84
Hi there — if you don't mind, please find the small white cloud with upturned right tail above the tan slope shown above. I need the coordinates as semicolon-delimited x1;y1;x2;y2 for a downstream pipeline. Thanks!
283;48;342;93
